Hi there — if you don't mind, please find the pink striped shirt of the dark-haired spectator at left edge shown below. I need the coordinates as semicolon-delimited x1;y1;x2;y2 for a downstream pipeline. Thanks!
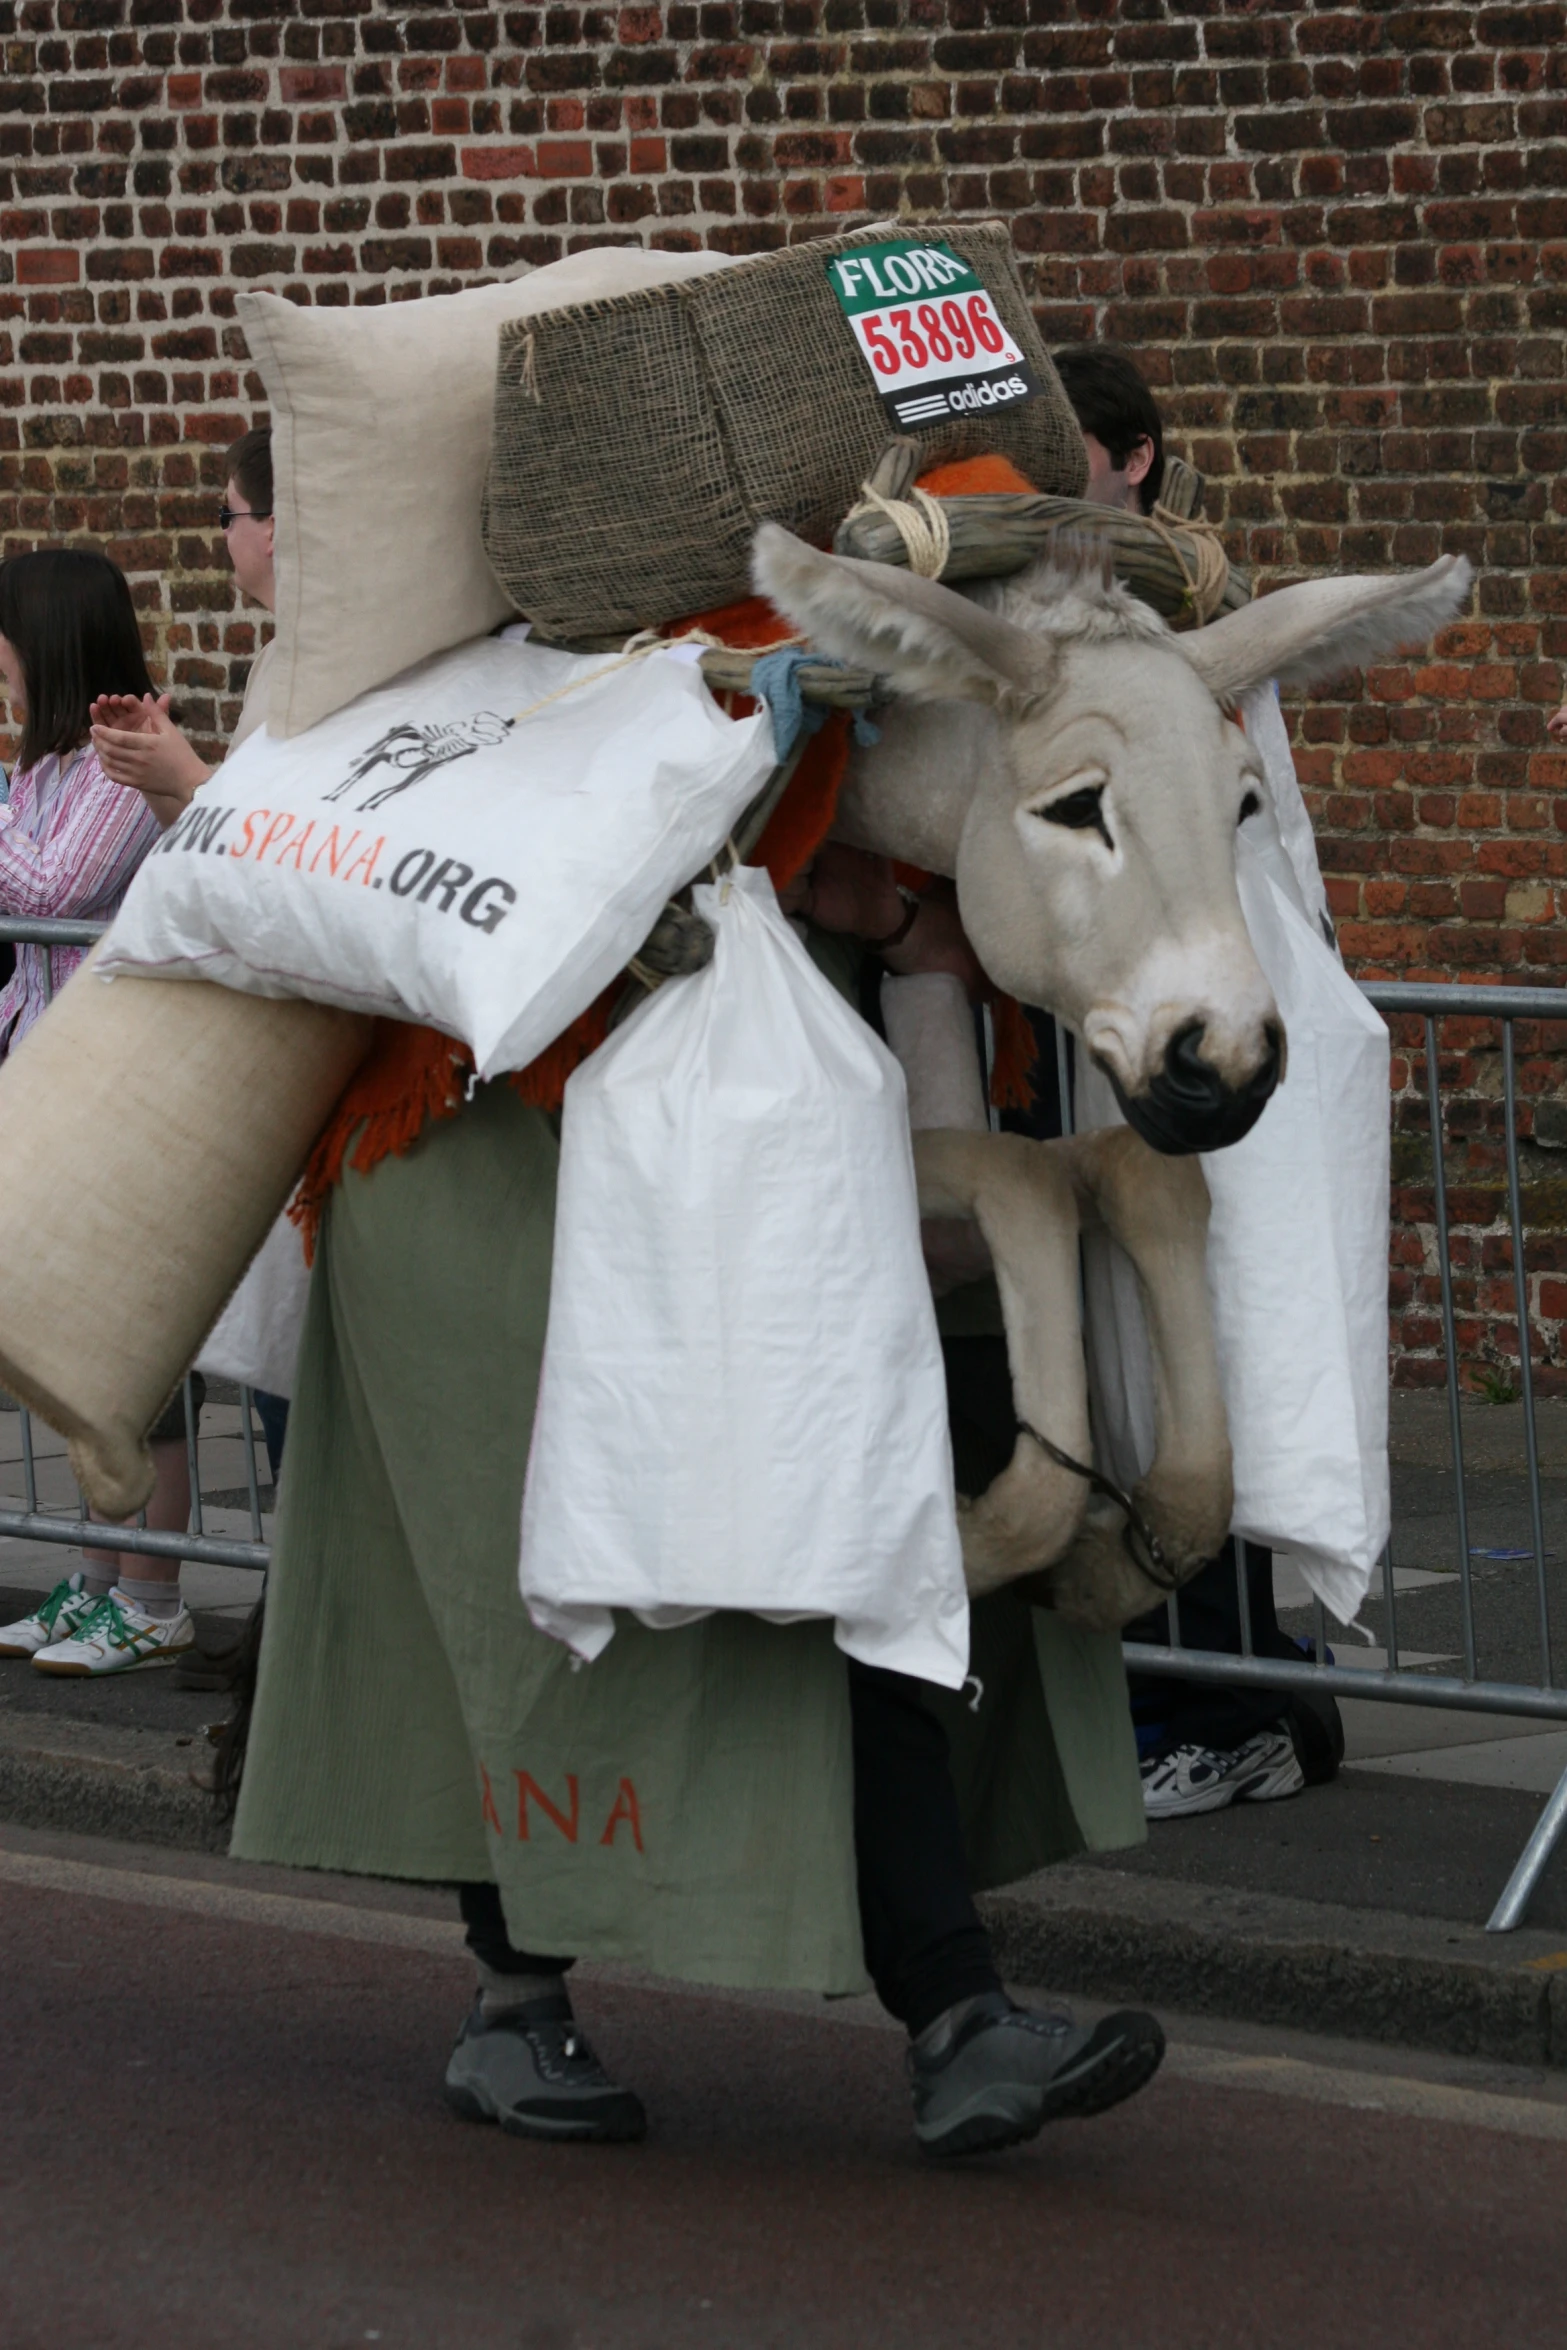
0;743;157;1053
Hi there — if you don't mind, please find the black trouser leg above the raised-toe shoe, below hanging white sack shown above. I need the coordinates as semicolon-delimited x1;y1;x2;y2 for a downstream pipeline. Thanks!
848;1657;1001;2033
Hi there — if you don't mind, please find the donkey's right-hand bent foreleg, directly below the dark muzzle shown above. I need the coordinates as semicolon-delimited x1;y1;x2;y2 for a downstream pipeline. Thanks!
1050;1126;1233;1631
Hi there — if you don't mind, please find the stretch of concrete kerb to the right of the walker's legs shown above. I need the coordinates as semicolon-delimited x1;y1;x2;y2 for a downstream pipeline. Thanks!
982;1866;1567;2068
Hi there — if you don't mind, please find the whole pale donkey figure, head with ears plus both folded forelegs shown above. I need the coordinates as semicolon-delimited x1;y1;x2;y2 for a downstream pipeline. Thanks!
756;526;1468;1631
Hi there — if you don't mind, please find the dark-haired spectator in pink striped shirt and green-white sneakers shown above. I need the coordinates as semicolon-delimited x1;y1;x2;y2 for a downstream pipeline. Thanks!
0;548;200;1673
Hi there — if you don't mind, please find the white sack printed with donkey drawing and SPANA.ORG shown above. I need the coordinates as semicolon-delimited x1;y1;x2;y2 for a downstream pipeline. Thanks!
101;637;773;1076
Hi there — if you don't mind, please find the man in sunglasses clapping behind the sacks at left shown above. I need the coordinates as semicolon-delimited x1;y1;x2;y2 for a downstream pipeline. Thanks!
89;428;277;827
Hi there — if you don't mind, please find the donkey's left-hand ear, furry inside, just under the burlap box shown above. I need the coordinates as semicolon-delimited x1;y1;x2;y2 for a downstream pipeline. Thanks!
752;522;1052;707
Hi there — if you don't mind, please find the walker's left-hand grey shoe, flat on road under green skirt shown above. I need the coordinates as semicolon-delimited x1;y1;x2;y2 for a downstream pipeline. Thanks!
446;1993;648;2143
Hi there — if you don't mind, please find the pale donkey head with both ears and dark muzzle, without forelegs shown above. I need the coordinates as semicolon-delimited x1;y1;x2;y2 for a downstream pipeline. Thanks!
756;524;1468;1154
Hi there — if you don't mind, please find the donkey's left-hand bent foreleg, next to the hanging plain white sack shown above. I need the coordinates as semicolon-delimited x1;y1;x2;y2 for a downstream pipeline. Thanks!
914;1130;1088;1598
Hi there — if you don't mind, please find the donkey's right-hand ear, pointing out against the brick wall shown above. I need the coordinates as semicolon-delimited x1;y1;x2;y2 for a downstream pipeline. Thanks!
1172;555;1471;698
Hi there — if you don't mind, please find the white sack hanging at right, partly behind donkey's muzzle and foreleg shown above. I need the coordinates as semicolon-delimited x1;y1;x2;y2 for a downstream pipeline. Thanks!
1078;834;1391;1622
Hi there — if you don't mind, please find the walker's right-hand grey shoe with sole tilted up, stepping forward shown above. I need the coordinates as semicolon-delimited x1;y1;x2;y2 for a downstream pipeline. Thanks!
909;1990;1165;2155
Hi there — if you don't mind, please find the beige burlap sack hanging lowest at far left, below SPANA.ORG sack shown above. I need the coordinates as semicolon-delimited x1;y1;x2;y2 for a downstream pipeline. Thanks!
0;949;371;1518
